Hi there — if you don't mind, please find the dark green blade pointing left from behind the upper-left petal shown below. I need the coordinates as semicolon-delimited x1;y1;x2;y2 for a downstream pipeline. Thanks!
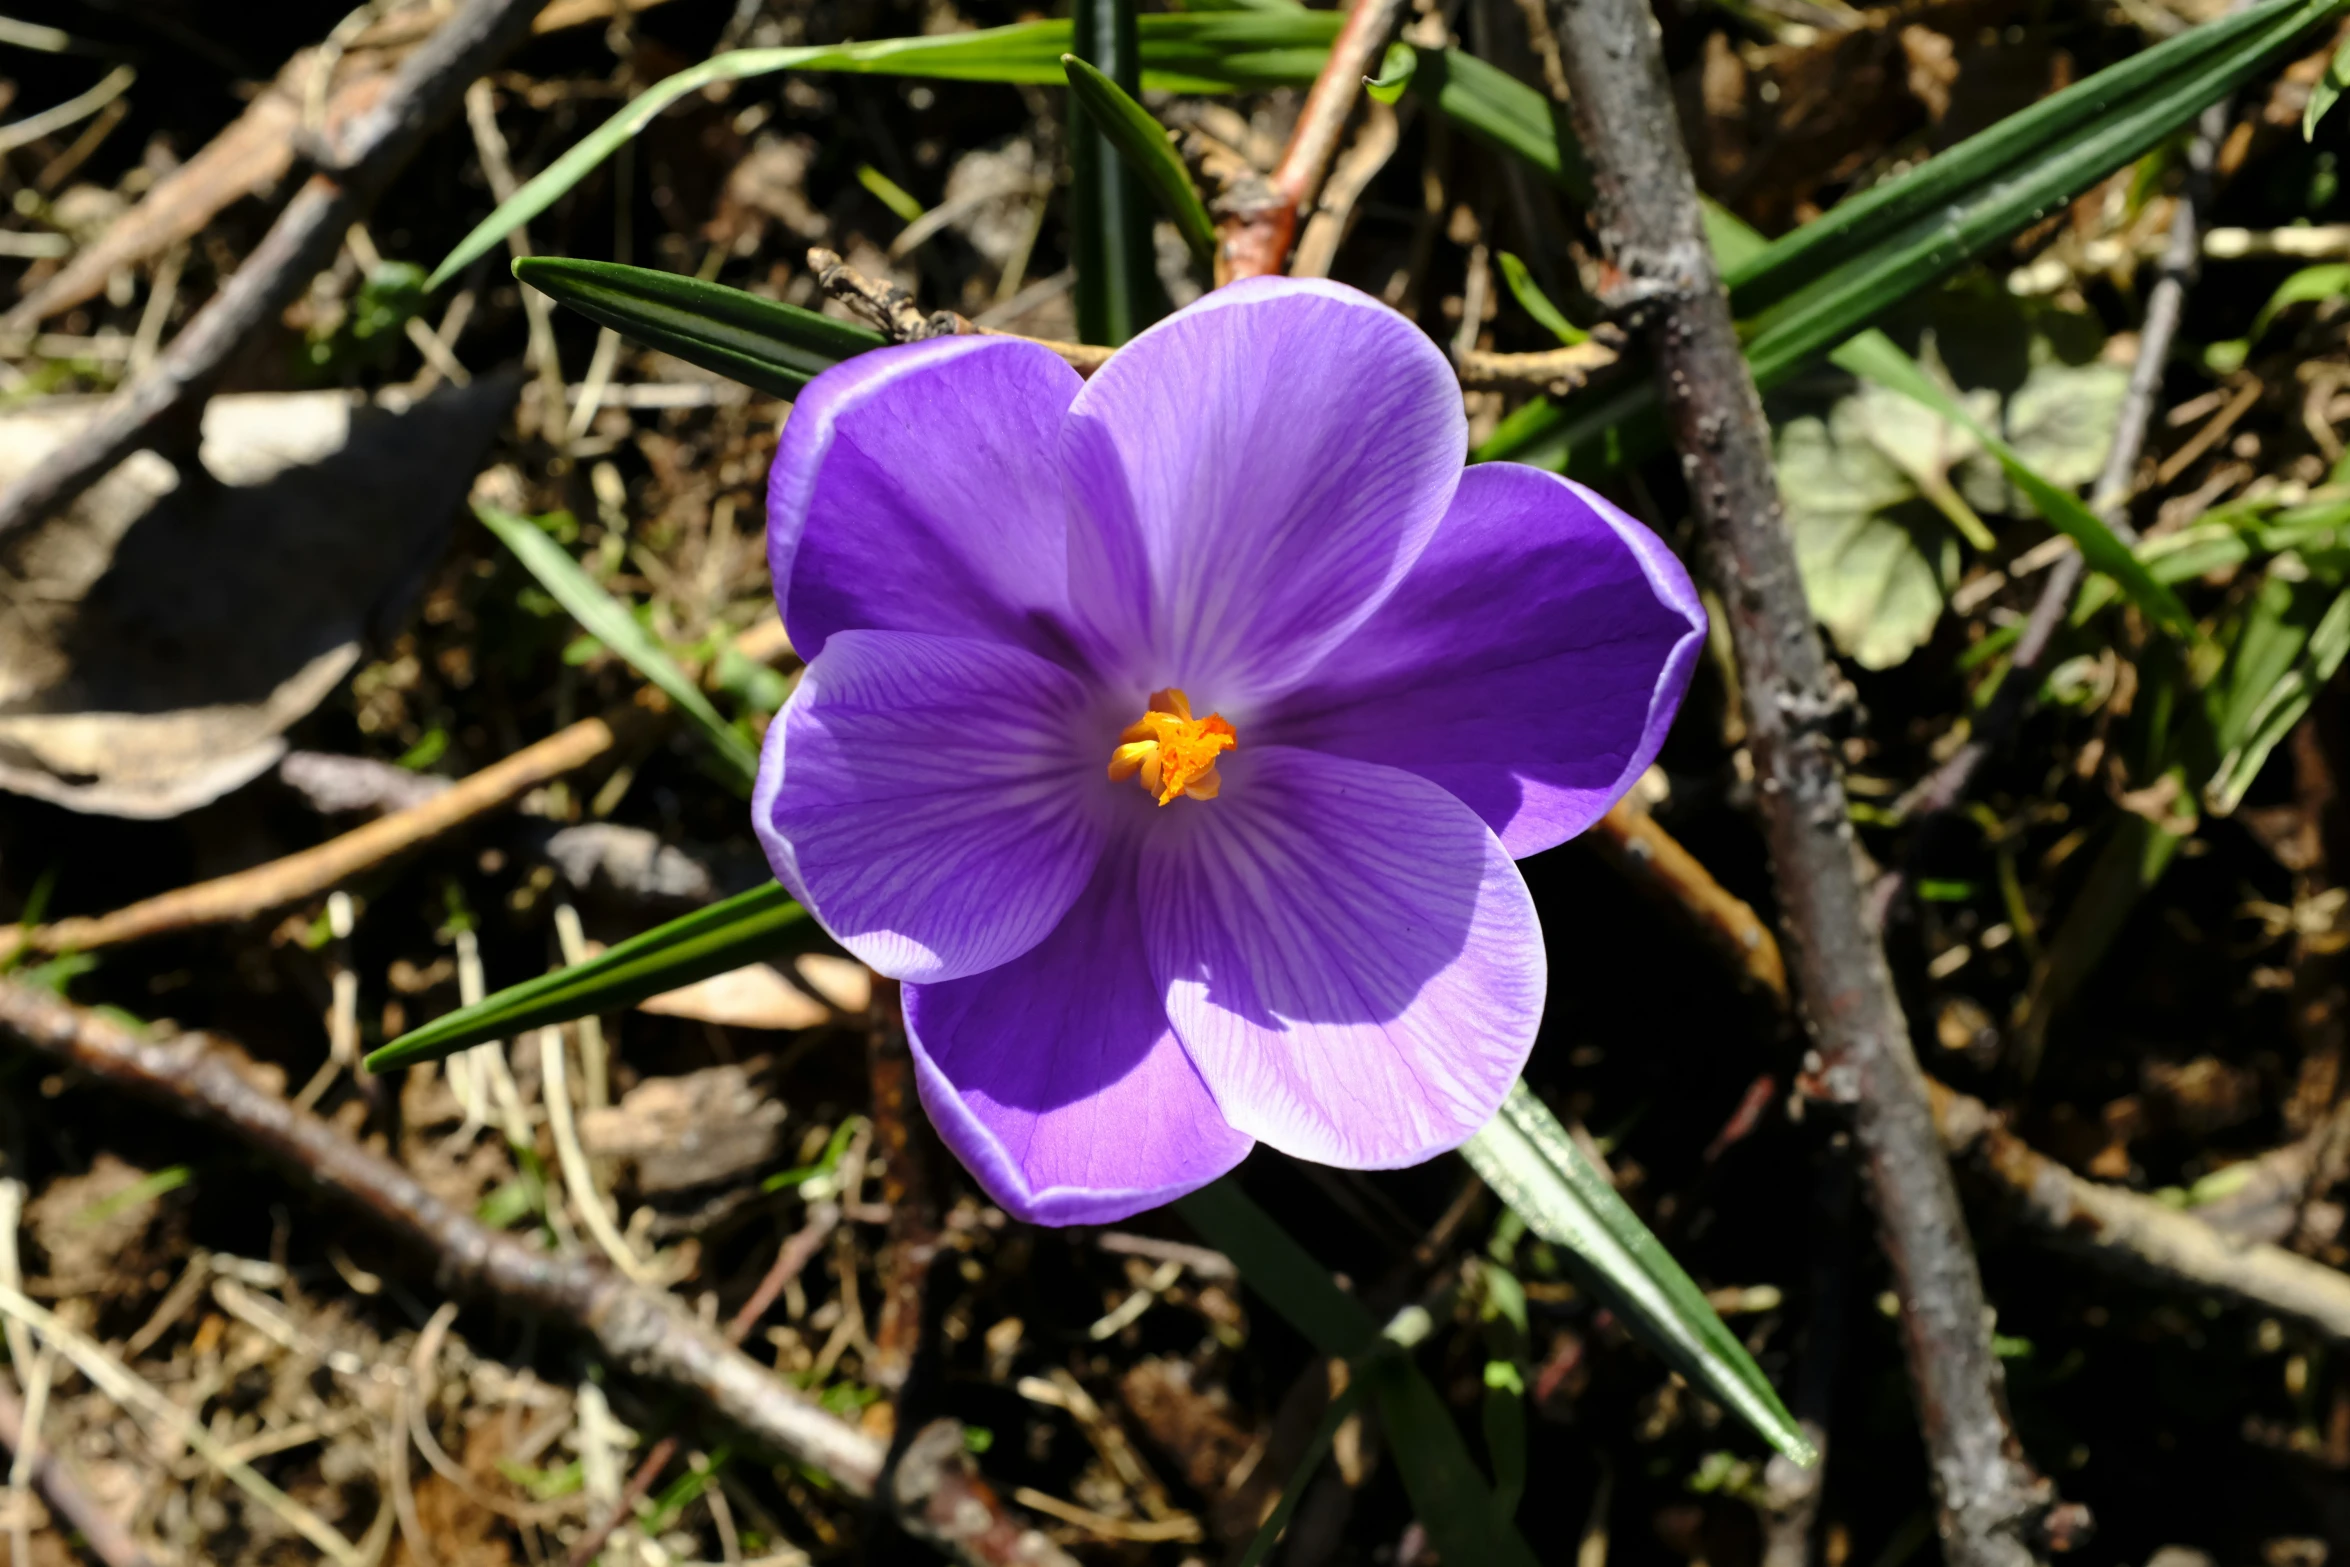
515;256;888;397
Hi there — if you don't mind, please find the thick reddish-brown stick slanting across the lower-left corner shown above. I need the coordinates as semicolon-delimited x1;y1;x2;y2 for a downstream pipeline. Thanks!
0;980;1072;1567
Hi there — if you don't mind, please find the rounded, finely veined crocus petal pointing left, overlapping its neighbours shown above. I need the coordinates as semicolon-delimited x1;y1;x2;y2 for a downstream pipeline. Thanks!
752;632;1109;980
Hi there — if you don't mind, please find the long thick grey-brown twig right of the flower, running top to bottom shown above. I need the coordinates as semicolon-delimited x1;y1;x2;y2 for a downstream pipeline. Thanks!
1551;0;2049;1567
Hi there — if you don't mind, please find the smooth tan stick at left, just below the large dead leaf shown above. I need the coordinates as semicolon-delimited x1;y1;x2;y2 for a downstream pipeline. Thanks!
0;707;649;959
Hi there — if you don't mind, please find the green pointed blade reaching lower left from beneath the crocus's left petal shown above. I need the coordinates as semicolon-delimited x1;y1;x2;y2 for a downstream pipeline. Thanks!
367;881;832;1071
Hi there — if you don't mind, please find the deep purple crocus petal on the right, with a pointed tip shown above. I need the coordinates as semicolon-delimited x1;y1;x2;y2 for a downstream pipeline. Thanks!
1243;463;1706;858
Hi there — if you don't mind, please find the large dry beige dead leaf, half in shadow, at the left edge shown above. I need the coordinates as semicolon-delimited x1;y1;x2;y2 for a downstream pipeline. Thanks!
0;376;515;818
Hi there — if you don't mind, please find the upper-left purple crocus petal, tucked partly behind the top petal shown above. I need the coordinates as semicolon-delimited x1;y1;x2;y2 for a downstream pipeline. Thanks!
766;336;1083;658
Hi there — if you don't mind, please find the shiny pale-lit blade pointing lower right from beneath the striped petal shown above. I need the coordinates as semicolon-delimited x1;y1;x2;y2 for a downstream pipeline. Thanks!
1462;1083;1817;1464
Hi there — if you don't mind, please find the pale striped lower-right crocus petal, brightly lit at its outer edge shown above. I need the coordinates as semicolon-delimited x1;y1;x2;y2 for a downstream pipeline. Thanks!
1142;742;1546;1170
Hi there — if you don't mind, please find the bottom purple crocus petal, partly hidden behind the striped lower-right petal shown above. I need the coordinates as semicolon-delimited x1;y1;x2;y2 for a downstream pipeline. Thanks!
905;850;1253;1224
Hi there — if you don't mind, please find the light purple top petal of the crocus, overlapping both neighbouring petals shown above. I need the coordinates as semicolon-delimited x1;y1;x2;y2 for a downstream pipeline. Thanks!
1062;277;1466;721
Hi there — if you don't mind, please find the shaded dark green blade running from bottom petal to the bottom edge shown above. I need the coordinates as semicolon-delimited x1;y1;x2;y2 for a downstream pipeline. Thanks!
1175;1177;1535;1567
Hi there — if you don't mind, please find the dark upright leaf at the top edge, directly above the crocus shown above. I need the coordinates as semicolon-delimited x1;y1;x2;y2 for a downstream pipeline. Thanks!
1062;0;1166;348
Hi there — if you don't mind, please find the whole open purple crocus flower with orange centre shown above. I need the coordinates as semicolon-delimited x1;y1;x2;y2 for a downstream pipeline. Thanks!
754;277;1704;1224
